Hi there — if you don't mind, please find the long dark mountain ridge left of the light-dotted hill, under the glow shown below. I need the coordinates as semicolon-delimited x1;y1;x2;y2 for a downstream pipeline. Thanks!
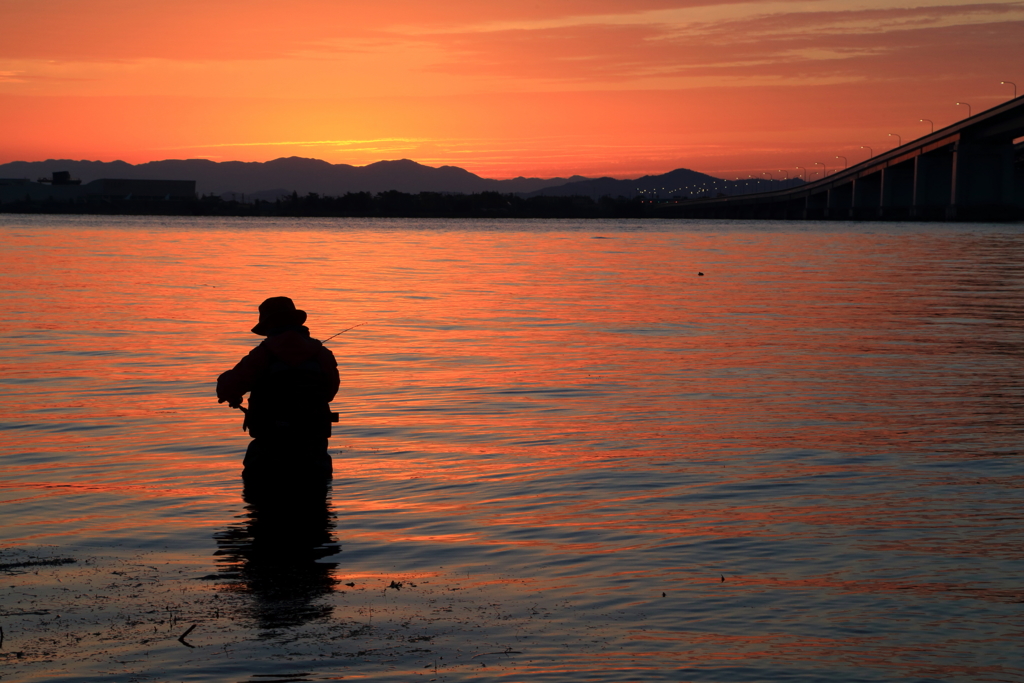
0;157;586;200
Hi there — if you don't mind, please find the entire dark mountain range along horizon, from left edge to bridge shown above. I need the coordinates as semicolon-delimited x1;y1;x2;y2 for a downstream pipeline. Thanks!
0;157;798;201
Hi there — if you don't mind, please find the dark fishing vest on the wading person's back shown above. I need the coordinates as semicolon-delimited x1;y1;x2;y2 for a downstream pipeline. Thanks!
242;347;334;440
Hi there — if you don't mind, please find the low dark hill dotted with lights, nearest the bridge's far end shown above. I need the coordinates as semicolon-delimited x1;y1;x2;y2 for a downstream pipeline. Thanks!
524;168;803;200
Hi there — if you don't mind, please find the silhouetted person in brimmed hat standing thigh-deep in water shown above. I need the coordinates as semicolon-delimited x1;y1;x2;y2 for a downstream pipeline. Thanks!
217;297;339;483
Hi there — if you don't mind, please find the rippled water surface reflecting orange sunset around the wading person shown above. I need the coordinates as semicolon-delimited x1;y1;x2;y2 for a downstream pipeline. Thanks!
0;215;1024;681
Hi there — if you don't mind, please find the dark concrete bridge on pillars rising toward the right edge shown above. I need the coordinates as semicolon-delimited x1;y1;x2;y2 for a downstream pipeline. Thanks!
658;95;1024;220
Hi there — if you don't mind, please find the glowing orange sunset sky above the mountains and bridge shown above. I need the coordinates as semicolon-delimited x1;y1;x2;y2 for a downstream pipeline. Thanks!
0;0;1024;178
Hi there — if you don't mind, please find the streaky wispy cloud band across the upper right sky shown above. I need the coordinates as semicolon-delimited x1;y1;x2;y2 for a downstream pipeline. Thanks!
403;0;1024;89
